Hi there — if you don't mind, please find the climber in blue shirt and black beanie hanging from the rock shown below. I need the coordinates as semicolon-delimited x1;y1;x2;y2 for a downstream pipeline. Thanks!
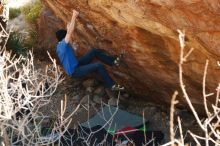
56;10;124;90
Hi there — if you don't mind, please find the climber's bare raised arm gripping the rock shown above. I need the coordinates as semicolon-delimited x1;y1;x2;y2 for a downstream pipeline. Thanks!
65;10;79;43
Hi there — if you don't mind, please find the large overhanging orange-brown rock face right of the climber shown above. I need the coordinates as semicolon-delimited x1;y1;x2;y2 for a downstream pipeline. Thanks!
43;0;220;112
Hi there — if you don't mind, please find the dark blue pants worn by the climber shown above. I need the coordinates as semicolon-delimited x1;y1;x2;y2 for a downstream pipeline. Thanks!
72;49;115;88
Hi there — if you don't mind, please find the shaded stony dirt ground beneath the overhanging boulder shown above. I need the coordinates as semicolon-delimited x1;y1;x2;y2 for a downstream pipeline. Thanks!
36;62;203;142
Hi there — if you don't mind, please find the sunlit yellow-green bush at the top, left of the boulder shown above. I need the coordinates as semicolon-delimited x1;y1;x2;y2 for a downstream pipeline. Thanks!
21;1;42;23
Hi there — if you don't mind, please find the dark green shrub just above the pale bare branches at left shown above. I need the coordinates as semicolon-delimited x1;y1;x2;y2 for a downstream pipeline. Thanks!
6;31;27;56
